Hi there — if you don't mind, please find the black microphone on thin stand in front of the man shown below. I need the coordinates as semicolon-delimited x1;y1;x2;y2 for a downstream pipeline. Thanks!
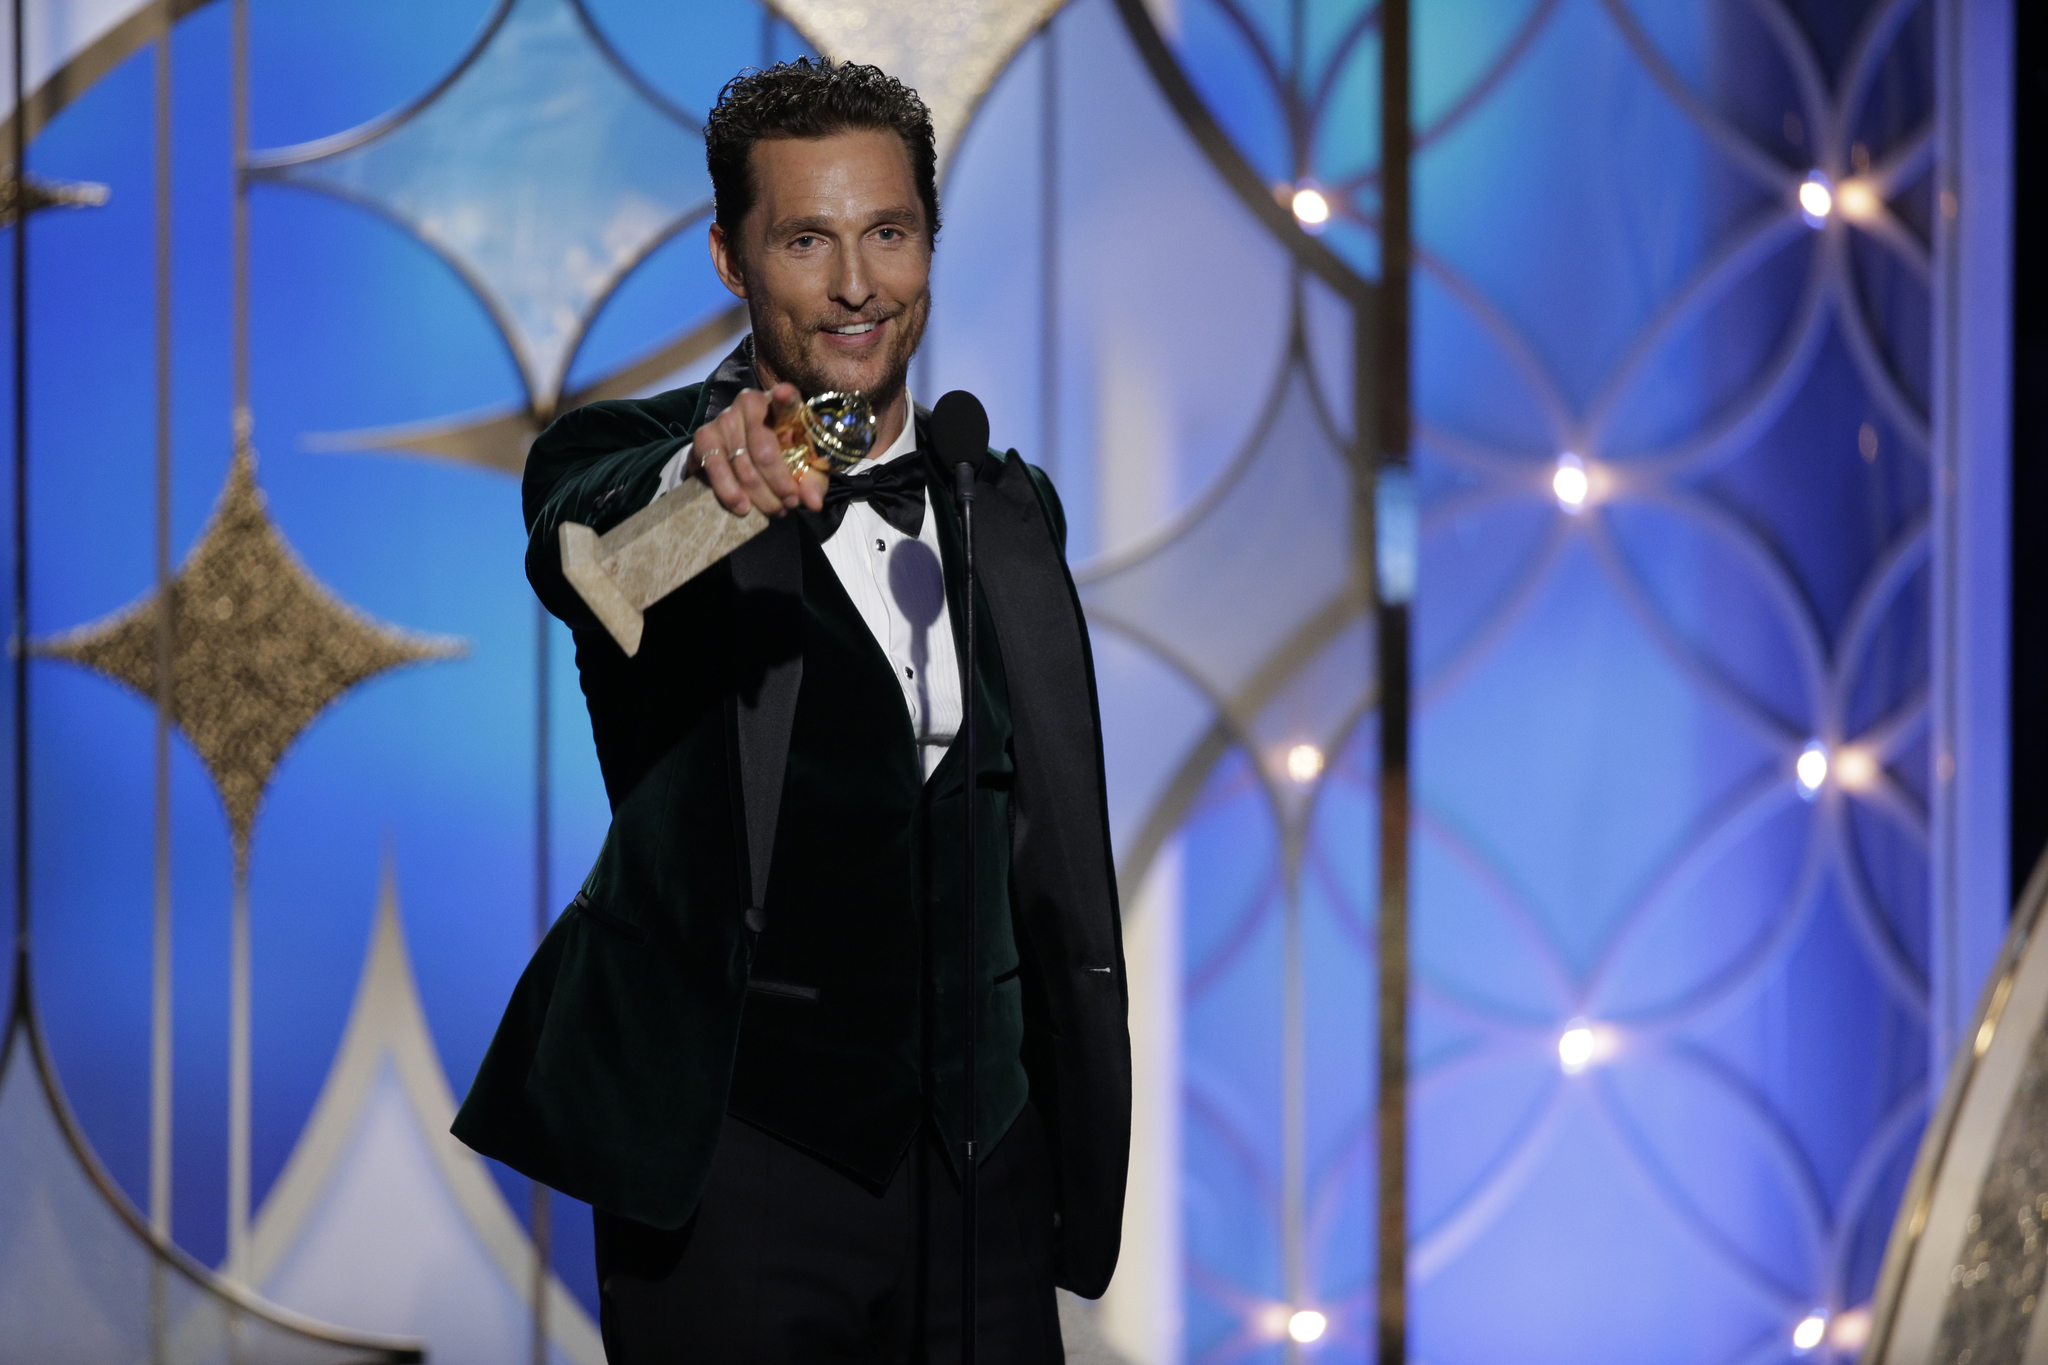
928;389;989;1365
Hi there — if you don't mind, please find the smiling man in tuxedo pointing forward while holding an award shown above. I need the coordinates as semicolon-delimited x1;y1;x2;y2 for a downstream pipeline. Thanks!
455;61;1130;1365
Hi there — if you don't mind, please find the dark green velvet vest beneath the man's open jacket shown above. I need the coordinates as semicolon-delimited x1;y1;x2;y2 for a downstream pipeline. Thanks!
727;470;1028;1185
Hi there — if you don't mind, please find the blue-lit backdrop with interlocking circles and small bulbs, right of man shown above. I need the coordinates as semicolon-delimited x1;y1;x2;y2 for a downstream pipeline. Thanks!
1122;0;1933;1361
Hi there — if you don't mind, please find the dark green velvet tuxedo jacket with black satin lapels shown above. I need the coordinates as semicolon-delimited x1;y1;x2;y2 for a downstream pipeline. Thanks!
455;342;1130;1297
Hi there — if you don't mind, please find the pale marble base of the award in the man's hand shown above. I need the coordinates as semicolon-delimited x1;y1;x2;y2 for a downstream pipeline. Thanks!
561;479;768;657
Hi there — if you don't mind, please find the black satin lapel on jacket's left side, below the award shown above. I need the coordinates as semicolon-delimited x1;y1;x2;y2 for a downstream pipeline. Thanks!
727;518;803;907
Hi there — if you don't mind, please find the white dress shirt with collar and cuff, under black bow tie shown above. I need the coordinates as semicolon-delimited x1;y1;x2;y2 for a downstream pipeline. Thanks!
655;393;961;778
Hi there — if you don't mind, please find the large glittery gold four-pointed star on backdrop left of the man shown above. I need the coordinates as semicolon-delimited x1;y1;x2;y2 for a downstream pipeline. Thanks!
35;450;463;853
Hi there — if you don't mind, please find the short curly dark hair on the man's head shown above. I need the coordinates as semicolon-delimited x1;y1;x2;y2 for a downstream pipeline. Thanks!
705;57;938;253
